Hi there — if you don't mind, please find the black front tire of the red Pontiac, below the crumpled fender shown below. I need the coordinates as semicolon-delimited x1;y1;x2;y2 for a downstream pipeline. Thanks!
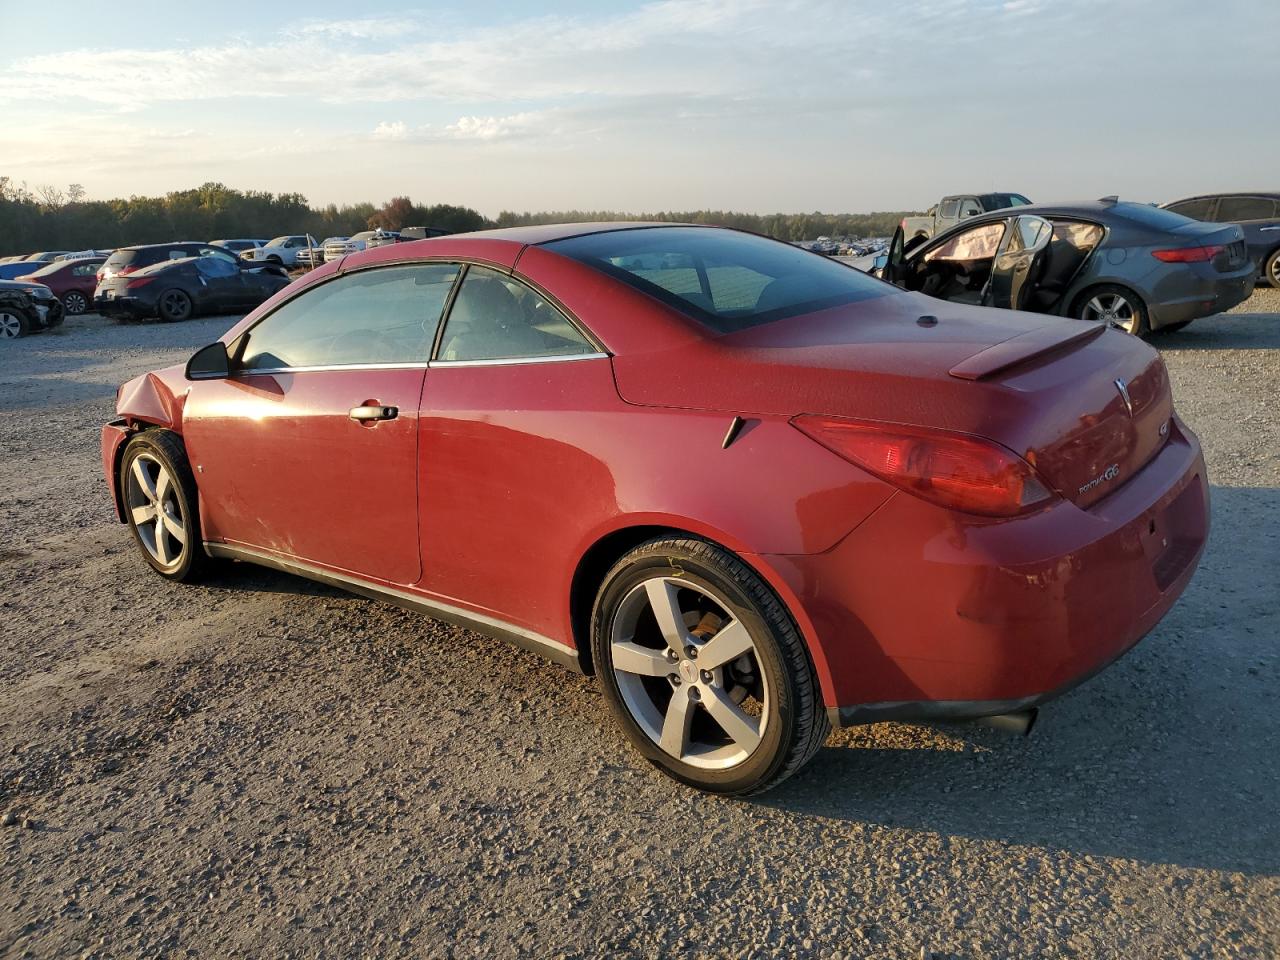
119;429;210;584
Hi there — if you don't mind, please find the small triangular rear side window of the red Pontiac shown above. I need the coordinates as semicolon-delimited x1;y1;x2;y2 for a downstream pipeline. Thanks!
436;266;595;361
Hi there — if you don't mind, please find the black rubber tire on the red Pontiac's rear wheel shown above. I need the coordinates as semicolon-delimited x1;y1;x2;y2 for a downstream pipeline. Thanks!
591;536;831;796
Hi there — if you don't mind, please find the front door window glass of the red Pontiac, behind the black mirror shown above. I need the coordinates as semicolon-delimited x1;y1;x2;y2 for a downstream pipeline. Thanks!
239;264;458;371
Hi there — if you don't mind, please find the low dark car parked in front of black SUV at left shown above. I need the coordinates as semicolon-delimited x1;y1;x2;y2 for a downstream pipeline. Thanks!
93;247;289;323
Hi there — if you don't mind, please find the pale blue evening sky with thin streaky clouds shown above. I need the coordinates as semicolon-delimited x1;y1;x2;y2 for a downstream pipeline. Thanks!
0;0;1280;216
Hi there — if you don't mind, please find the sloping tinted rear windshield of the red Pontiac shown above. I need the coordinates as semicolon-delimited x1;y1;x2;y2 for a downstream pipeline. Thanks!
545;227;893;333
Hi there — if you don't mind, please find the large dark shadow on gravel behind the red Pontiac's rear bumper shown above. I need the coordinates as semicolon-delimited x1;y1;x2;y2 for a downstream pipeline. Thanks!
751;486;1280;876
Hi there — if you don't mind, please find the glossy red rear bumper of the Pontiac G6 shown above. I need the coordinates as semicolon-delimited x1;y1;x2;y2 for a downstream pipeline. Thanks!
762;424;1208;724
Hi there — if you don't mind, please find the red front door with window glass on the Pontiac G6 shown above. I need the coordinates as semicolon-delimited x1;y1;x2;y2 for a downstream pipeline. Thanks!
183;264;458;584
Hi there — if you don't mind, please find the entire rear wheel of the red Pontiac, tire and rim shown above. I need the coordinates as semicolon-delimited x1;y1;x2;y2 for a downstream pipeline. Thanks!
591;538;829;795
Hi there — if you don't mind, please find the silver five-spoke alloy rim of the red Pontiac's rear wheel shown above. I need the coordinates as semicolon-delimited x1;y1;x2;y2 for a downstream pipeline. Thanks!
609;577;772;769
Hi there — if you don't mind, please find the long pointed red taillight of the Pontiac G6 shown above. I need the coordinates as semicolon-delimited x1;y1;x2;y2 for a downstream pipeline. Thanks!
791;415;1055;517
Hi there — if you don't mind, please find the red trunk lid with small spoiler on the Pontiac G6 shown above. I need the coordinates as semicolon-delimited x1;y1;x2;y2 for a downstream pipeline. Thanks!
613;293;1172;506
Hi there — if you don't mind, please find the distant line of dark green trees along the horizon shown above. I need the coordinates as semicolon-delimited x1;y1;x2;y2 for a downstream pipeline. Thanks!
0;177;921;256
